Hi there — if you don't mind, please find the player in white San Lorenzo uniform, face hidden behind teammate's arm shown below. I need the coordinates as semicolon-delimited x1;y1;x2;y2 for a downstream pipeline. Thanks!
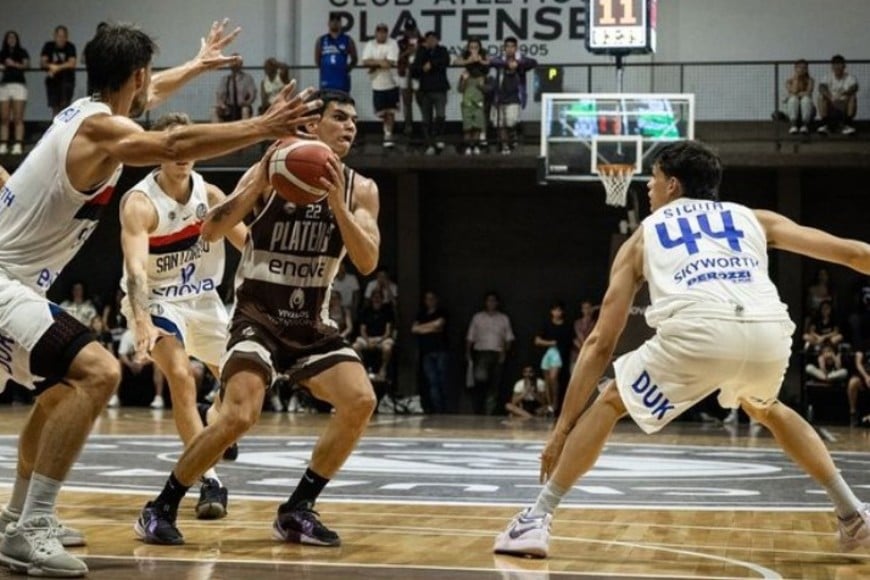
121;113;247;520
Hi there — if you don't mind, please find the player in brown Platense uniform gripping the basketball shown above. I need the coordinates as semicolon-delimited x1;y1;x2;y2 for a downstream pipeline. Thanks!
136;91;380;546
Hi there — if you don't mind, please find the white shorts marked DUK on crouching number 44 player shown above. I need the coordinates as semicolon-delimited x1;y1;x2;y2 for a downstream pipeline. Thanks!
613;317;795;433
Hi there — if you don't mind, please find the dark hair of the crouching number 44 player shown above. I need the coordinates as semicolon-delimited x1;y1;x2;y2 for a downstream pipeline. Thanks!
655;141;722;201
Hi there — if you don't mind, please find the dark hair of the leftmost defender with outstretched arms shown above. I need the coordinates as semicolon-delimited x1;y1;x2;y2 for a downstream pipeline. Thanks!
85;24;157;93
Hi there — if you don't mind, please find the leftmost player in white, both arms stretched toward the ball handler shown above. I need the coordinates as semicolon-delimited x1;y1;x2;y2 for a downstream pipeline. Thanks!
0;22;316;576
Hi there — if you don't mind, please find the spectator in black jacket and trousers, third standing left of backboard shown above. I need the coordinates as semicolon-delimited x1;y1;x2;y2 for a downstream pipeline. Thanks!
411;31;450;155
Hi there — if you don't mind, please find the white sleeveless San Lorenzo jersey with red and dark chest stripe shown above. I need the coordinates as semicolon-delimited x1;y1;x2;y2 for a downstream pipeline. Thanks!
121;170;224;301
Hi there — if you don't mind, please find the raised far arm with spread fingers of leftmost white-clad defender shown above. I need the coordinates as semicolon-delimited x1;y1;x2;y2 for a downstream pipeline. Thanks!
145;18;242;109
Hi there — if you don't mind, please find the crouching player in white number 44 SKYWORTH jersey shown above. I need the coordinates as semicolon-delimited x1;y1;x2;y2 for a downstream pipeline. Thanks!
495;142;870;557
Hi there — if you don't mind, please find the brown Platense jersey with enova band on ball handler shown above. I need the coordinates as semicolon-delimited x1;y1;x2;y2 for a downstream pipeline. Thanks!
230;168;354;359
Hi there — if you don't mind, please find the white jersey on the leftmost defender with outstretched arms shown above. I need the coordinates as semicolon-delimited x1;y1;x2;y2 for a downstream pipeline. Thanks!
0;98;123;295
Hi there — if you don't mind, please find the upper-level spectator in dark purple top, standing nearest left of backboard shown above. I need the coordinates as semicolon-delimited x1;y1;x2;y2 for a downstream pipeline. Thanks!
489;36;538;154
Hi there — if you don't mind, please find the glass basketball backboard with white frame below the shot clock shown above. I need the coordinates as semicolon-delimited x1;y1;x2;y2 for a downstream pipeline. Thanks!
540;93;695;181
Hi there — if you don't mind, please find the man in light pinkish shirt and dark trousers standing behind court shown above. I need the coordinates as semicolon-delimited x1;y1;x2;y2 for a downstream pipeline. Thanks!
465;292;514;415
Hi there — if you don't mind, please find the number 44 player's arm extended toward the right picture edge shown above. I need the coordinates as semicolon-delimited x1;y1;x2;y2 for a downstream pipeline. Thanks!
755;210;870;274
